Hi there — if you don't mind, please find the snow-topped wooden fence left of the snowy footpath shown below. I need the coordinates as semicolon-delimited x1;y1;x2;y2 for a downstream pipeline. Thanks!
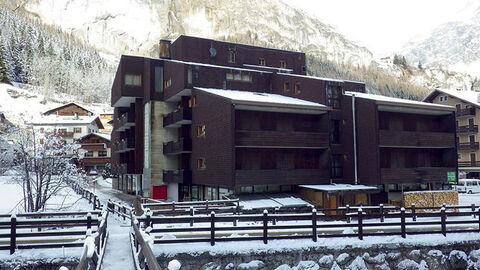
0;211;102;254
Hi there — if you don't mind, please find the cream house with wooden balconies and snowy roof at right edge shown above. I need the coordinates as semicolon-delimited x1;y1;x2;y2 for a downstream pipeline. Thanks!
424;89;480;178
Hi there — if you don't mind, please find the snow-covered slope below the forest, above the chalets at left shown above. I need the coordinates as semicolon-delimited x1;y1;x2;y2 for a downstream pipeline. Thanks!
0;83;112;126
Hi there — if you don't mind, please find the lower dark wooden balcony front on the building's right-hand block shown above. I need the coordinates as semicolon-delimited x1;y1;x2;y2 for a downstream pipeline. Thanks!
380;167;455;183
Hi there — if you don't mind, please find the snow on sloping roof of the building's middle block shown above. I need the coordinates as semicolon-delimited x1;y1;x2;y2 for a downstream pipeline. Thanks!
195;87;327;109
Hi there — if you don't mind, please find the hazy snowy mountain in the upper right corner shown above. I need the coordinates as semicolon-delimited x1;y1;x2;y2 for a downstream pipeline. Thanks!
402;2;480;76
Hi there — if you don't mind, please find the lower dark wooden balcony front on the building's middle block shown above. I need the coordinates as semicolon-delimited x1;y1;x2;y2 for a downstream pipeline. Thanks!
235;169;330;186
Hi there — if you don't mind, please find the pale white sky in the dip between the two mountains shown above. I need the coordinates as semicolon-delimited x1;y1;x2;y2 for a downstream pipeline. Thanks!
283;0;480;57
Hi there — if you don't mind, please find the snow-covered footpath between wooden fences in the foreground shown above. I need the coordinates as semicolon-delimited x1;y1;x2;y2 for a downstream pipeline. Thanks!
102;214;135;270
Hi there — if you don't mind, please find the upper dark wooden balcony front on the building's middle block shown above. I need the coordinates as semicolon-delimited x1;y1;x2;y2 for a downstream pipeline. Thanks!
235;130;329;148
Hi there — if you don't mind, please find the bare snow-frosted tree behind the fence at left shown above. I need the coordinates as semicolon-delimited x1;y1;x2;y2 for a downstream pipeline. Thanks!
7;128;82;212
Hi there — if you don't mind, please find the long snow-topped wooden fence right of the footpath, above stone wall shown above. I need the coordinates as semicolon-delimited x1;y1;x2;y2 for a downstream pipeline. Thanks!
138;206;480;246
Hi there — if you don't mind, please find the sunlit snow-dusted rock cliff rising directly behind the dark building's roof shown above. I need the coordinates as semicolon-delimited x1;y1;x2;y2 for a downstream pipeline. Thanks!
24;0;373;65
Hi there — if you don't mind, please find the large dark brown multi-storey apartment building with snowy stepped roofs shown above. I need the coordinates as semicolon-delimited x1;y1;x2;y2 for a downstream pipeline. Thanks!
111;36;457;204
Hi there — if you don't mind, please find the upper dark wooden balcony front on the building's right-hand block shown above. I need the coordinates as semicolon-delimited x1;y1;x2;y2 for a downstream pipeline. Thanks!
379;130;455;148
